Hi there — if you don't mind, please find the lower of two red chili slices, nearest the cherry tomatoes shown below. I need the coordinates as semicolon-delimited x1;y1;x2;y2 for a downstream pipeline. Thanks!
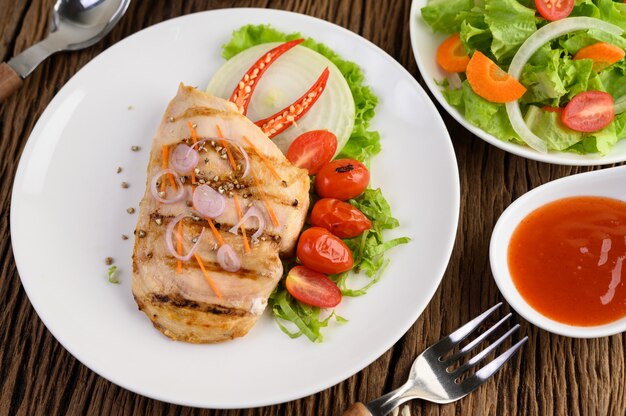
254;68;330;139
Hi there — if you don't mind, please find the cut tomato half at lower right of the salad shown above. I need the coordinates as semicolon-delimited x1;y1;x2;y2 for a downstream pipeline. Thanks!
561;91;615;133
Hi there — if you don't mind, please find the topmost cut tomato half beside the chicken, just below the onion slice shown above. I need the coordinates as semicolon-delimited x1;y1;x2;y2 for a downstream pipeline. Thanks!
287;130;337;175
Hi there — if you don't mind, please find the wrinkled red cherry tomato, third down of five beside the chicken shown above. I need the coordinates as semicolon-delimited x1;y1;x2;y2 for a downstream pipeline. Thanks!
311;198;372;238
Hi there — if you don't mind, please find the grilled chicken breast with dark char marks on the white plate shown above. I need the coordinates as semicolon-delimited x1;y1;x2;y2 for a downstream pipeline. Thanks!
132;84;309;343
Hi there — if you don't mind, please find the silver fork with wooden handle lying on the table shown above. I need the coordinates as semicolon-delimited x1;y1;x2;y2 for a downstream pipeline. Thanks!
343;303;528;416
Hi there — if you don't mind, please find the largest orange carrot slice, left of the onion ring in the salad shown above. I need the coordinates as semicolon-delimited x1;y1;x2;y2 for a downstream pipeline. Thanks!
466;51;526;103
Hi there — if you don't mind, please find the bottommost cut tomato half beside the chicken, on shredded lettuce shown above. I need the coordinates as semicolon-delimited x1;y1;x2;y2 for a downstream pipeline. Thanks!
285;266;341;308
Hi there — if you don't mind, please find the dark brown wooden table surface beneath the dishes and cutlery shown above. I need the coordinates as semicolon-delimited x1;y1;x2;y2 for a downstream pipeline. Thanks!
0;0;626;415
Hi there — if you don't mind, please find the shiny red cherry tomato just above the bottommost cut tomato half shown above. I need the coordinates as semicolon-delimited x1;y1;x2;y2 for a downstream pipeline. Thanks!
296;227;354;274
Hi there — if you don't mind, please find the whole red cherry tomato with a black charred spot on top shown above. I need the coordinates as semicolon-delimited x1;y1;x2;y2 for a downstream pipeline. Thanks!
315;159;370;201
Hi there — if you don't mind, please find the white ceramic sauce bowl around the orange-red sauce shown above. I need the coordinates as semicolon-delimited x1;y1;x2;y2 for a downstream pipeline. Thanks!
489;166;626;338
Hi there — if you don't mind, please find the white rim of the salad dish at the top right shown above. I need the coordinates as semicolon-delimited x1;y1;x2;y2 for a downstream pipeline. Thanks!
409;0;626;166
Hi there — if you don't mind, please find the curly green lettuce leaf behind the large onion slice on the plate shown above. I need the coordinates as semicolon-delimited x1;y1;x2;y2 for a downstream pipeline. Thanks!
222;25;381;163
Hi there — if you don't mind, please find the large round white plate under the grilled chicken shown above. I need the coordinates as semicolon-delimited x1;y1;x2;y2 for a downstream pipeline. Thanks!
11;9;460;408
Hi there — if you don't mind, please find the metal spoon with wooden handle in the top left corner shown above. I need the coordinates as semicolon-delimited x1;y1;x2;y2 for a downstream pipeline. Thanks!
0;0;130;101
